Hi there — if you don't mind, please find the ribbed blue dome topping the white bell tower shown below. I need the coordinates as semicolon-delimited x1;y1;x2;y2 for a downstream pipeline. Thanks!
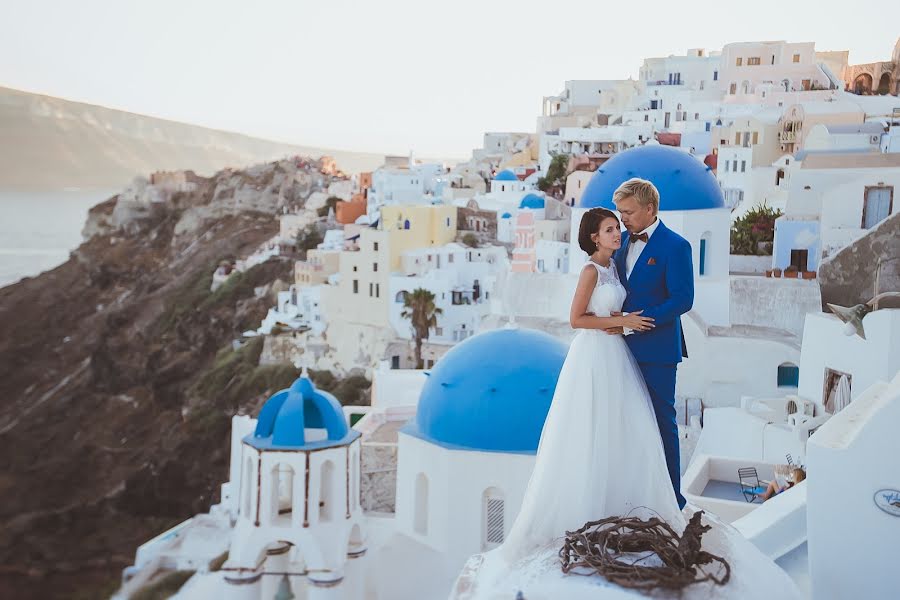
244;376;360;450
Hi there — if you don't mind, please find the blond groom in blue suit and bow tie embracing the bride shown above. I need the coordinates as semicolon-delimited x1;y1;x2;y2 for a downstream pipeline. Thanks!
613;178;694;508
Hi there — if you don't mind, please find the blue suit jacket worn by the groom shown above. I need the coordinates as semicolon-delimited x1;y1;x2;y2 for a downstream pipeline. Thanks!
613;221;694;364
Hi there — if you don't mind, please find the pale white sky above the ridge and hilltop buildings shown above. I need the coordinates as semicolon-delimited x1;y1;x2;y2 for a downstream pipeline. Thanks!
0;0;900;158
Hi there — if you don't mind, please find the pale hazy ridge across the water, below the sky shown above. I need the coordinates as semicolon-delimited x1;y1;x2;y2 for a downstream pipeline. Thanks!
0;87;384;190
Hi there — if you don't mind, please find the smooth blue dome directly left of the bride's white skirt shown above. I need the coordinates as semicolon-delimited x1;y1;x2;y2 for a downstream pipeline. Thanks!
403;328;566;454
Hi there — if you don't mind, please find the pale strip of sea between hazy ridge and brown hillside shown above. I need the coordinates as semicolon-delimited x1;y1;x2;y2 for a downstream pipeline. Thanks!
0;189;115;287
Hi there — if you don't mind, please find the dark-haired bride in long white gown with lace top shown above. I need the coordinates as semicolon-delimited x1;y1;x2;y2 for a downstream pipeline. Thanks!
501;208;684;560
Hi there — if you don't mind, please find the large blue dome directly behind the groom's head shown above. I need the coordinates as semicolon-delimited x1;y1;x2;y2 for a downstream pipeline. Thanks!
580;146;725;211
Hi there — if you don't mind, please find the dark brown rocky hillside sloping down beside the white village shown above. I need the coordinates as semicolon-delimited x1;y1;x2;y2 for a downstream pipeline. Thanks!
0;160;335;598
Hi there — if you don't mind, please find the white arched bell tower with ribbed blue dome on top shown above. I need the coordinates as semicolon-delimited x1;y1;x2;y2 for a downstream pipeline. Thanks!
220;377;366;600
